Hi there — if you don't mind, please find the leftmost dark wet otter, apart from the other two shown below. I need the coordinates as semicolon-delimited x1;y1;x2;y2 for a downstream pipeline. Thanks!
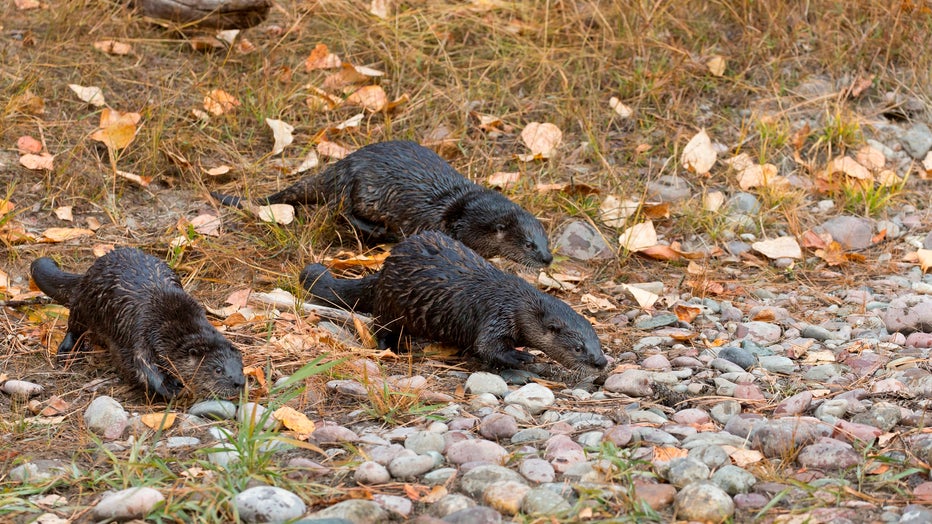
30;248;246;400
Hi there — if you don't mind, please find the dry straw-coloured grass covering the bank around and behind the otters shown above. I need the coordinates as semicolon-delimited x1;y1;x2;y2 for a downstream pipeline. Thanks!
0;0;932;520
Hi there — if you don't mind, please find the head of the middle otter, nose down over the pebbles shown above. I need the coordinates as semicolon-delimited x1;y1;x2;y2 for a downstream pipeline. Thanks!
518;294;608;373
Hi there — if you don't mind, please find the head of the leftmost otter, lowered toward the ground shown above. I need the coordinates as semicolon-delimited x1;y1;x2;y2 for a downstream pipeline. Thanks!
181;331;246;398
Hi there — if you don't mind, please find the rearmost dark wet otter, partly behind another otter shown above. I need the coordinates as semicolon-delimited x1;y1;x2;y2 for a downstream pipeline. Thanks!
211;141;553;267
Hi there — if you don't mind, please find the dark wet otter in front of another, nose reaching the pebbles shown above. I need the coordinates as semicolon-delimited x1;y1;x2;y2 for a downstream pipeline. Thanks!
299;231;607;373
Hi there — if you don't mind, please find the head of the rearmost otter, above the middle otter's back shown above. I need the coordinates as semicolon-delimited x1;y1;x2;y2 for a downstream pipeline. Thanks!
456;205;553;267
